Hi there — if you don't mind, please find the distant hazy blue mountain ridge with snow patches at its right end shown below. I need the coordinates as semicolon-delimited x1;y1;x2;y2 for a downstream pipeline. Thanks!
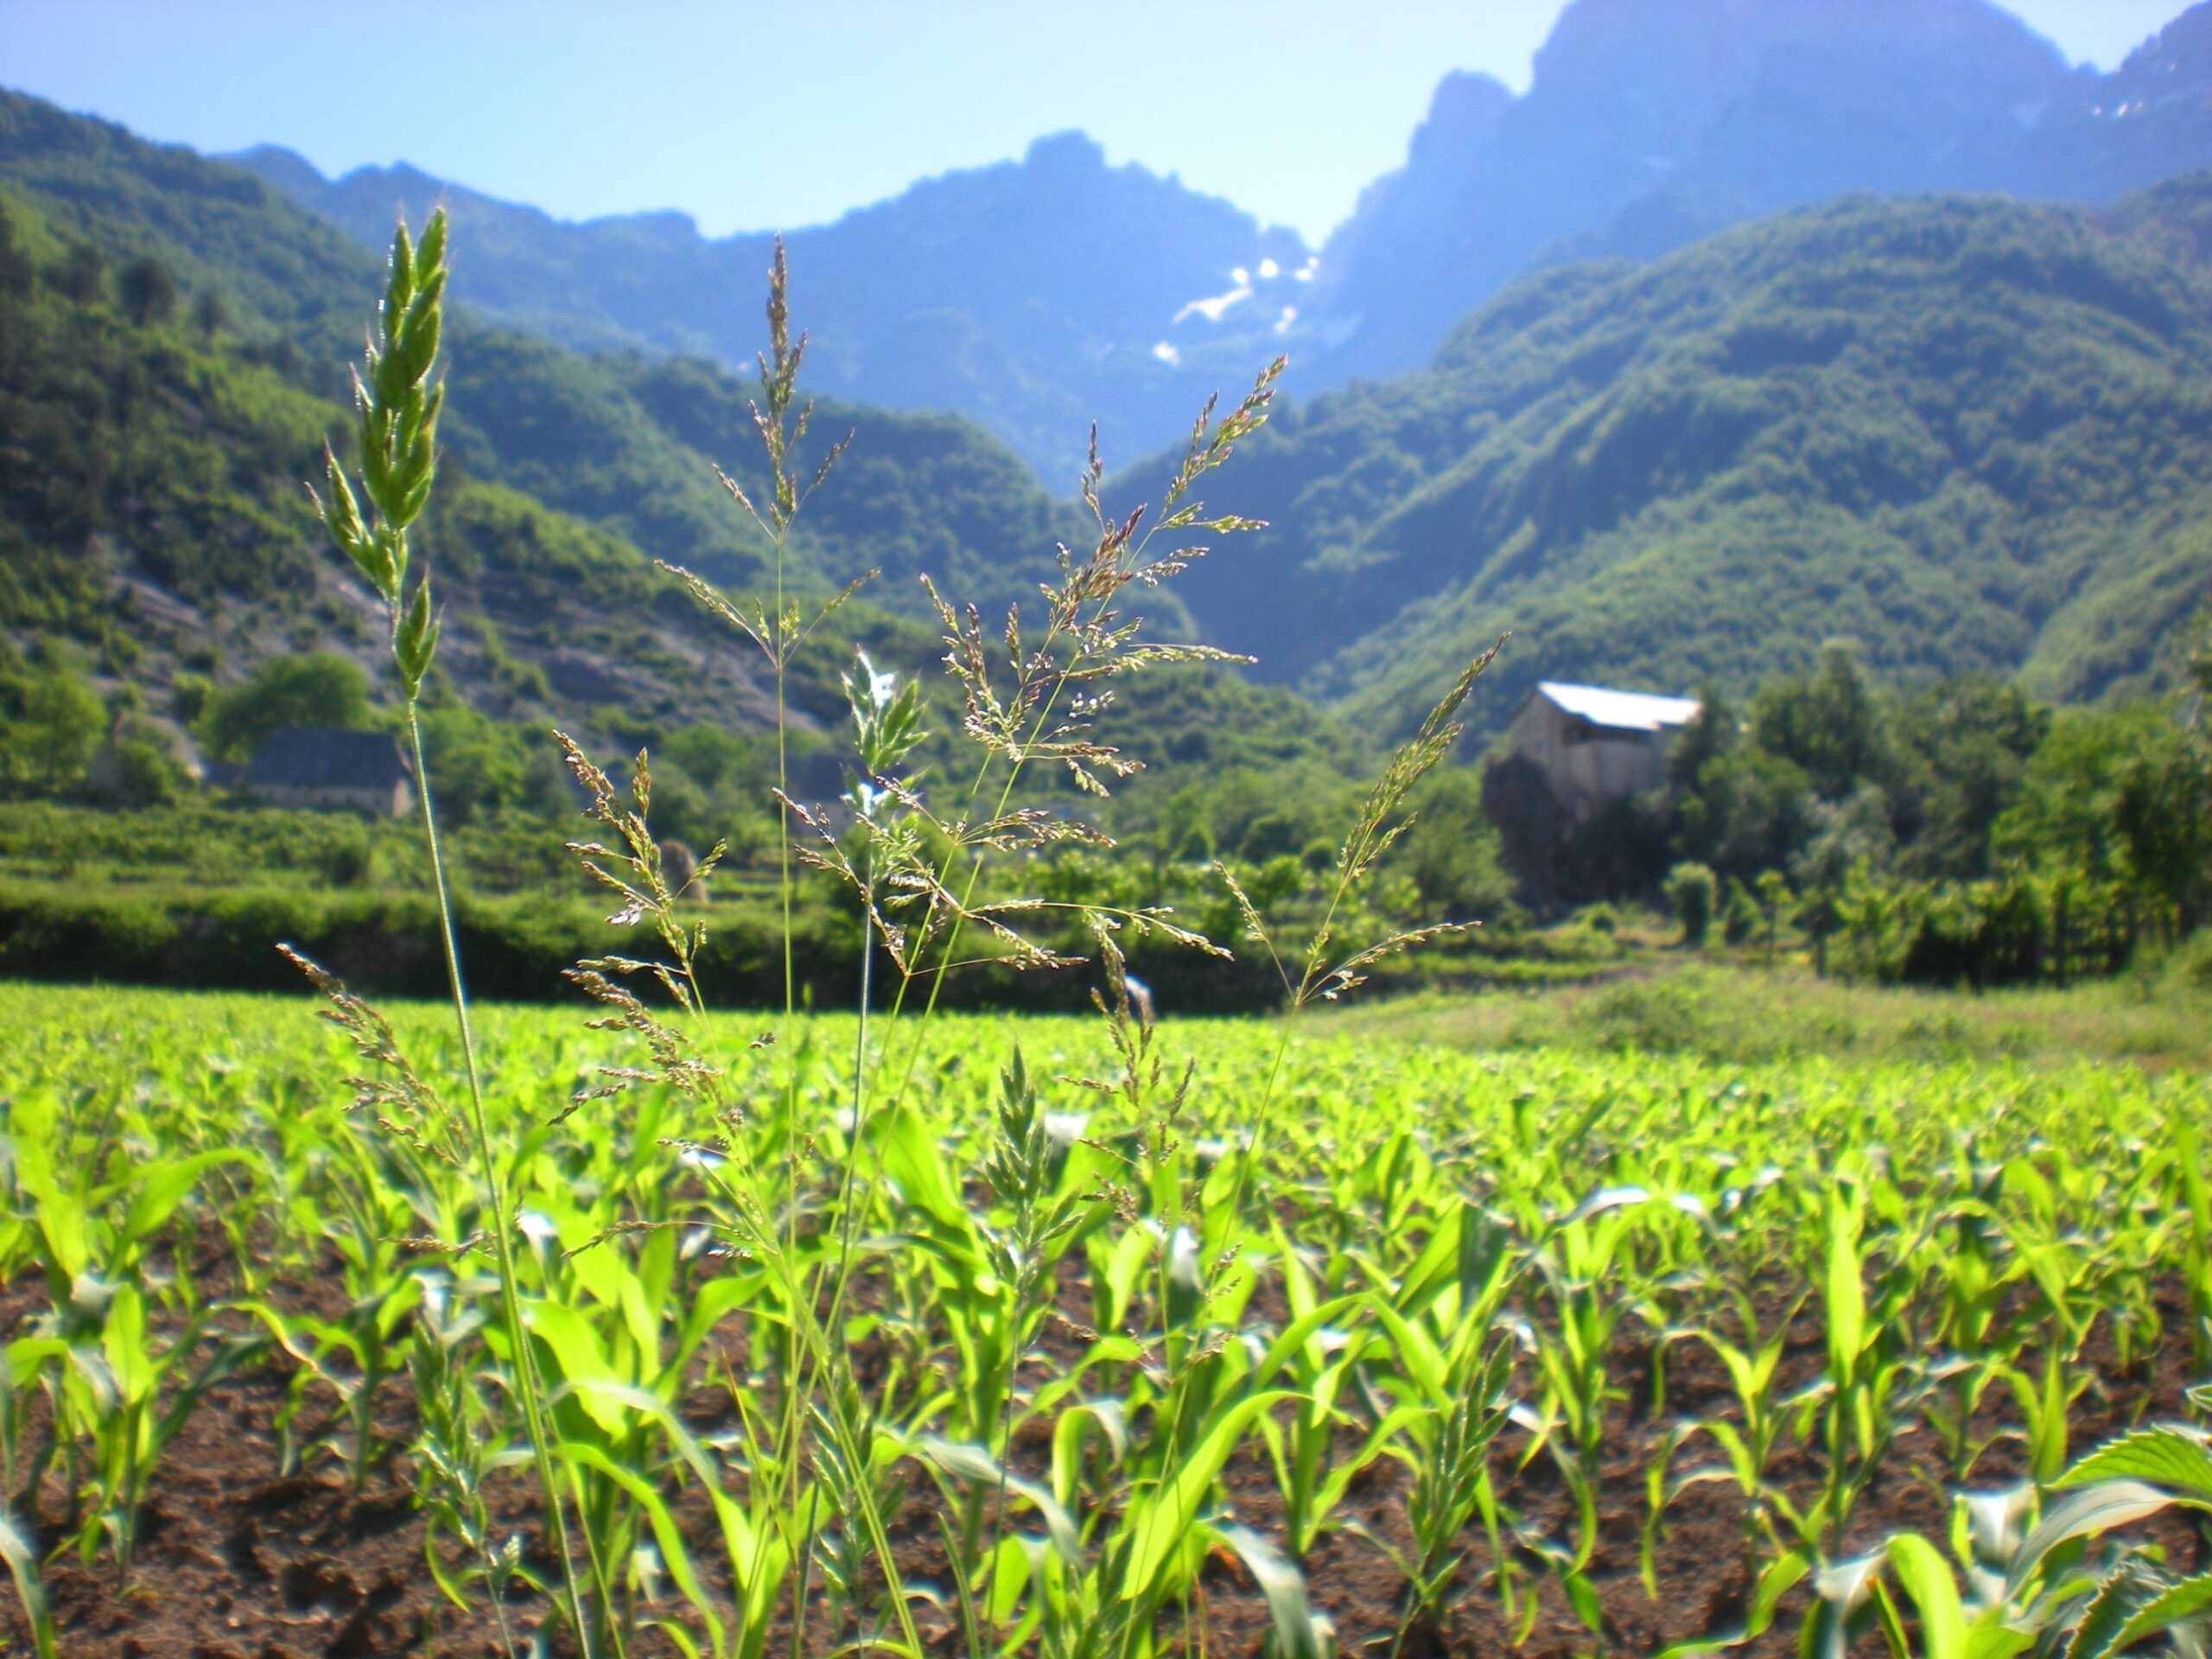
230;133;1307;491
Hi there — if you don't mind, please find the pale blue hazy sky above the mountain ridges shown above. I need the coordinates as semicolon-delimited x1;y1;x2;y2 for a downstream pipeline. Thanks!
0;0;2185;241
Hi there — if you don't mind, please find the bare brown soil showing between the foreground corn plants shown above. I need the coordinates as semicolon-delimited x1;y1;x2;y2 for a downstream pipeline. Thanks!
0;1263;2205;1659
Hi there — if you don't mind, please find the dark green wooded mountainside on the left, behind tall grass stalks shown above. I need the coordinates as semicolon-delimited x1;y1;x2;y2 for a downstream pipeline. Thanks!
0;93;1123;728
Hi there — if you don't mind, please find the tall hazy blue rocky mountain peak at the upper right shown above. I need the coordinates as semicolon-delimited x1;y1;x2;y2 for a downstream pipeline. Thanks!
1299;0;2212;385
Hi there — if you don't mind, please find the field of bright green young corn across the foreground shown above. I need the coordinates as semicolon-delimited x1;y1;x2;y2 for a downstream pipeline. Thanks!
0;987;2212;1655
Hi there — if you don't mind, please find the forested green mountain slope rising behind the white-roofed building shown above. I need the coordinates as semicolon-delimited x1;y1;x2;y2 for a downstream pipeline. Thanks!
1109;175;2212;728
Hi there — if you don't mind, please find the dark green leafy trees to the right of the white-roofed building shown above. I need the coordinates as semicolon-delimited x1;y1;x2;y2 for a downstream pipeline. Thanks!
1489;646;2212;987
